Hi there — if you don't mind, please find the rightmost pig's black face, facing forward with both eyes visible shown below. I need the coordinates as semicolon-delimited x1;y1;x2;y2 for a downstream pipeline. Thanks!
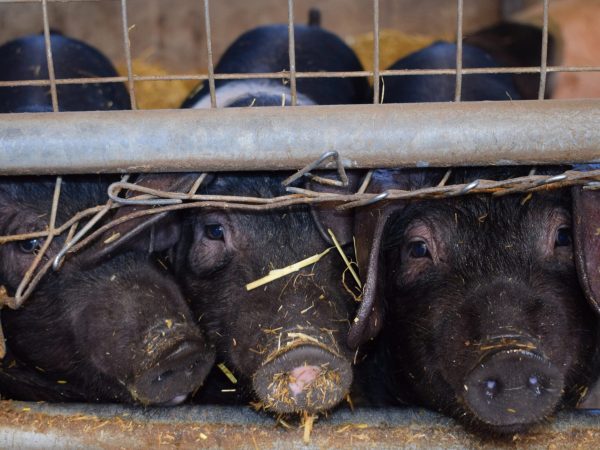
383;186;596;432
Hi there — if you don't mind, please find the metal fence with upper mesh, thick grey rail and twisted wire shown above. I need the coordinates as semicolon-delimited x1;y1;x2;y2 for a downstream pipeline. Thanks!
0;0;600;446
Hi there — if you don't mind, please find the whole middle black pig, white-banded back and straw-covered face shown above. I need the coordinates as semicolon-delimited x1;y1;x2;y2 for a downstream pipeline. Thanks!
114;14;368;413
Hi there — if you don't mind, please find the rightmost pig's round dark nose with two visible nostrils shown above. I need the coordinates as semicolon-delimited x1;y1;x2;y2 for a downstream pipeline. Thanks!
463;349;564;430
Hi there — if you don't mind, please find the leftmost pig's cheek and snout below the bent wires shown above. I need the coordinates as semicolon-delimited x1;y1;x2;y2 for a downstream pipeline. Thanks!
2;255;212;404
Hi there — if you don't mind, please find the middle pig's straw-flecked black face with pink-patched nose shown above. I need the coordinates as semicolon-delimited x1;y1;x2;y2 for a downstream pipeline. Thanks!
171;175;353;412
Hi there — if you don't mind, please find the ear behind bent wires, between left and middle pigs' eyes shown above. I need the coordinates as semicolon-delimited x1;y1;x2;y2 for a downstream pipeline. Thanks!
86;173;206;263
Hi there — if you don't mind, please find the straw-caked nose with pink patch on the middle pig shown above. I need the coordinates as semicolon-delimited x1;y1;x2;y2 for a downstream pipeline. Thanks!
253;344;352;413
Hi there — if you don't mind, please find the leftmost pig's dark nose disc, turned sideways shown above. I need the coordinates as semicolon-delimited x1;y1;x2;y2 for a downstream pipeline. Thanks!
129;339;215;406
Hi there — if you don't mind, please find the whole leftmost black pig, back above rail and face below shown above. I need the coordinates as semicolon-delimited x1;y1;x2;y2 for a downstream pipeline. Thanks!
0;34;214;404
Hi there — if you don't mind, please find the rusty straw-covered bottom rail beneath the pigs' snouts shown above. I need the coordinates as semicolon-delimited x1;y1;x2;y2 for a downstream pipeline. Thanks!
0;401;600;449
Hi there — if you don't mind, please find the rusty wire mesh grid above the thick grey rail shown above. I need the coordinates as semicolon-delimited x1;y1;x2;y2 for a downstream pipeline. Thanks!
0;0;600;97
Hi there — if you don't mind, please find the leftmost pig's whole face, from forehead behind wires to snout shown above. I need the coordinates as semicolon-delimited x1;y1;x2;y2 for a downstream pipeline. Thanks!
0;179;214;404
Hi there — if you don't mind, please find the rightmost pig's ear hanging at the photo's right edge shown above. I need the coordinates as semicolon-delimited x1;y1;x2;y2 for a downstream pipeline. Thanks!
572;187;600;313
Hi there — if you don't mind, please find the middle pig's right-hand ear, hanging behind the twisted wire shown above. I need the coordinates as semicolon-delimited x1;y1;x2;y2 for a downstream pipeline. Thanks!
306;171;363;246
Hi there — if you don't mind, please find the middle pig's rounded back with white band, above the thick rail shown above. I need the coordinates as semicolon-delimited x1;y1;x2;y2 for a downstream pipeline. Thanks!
183;12;369;108
